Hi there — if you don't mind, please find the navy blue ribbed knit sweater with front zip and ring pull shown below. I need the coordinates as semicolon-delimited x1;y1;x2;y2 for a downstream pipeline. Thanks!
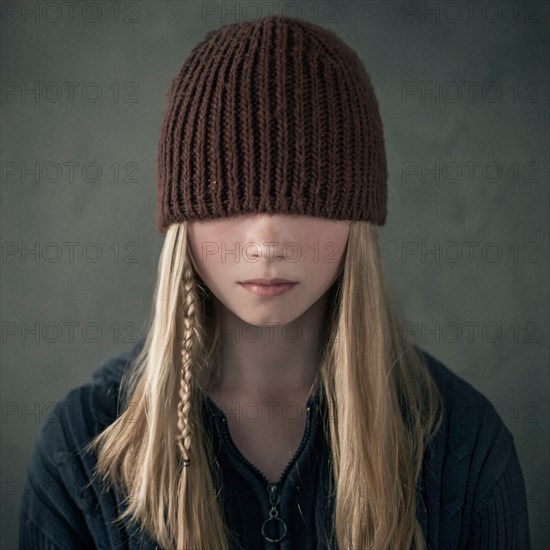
20;340;530;550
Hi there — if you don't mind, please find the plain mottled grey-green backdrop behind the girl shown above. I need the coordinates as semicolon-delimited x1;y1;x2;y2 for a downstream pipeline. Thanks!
0;1;550;550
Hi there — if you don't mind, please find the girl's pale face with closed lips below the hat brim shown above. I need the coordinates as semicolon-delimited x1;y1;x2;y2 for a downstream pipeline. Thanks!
188;213;350;325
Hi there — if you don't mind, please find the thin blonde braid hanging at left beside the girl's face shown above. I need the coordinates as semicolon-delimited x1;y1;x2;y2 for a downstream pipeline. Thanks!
176;264;196;467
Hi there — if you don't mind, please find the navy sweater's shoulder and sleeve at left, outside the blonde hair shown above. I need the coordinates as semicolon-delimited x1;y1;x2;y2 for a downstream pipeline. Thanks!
20;342;147;548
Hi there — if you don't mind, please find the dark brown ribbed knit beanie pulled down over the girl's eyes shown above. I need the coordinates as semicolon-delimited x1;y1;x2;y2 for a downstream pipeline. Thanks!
157;15;387;235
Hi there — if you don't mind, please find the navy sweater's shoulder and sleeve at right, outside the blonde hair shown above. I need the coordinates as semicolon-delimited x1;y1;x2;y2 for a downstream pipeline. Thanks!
416;347;529;548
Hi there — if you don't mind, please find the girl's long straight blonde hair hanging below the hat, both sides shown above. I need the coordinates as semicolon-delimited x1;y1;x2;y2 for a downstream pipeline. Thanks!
88;221;443;550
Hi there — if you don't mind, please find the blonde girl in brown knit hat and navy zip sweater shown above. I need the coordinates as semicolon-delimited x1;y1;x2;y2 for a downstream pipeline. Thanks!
20;16;530;550
